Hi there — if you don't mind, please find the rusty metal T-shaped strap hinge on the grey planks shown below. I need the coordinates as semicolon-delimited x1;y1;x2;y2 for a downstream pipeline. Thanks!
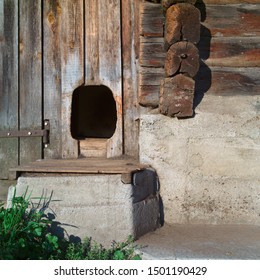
0;120;50;145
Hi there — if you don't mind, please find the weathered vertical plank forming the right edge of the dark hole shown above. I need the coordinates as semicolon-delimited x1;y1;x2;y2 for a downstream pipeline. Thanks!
99;0;123;157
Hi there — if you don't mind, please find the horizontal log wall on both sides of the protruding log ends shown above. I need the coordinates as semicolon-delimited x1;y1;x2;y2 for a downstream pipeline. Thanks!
139;0;260;107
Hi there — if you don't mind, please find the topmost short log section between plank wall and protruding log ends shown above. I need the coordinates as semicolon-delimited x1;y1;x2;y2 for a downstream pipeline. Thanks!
139;2;165;37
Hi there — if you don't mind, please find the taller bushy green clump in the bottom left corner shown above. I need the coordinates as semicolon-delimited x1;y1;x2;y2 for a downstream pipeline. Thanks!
0;189;59;259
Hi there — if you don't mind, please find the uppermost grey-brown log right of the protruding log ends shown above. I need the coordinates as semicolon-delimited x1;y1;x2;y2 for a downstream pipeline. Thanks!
201;3;260;37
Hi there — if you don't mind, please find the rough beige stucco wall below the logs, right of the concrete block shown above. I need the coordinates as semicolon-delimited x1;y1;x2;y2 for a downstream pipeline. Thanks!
139;96;260;225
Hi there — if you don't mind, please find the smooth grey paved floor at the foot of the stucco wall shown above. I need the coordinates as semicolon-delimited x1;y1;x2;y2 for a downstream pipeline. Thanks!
137;224;260;260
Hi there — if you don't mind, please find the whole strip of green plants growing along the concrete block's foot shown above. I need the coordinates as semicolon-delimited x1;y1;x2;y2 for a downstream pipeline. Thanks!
0;188;141;260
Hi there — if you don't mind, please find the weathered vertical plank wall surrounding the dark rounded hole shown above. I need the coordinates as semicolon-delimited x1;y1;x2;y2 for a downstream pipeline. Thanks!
0;0;140;179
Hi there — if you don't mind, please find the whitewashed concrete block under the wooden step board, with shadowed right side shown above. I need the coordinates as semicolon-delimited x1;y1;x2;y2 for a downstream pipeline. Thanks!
9;170;160;245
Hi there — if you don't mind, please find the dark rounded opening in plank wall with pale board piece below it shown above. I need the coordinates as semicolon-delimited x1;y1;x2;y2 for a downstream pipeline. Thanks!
71;85;117;157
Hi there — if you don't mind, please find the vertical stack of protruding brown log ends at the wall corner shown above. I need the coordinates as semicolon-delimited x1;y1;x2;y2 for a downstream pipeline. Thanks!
159;0;200;118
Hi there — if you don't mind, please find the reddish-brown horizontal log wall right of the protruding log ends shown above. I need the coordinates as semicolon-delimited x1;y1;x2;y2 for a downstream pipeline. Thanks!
197;0;260;96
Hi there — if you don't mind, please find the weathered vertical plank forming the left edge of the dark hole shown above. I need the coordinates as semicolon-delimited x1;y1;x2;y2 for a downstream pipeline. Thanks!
60;0;84;158
